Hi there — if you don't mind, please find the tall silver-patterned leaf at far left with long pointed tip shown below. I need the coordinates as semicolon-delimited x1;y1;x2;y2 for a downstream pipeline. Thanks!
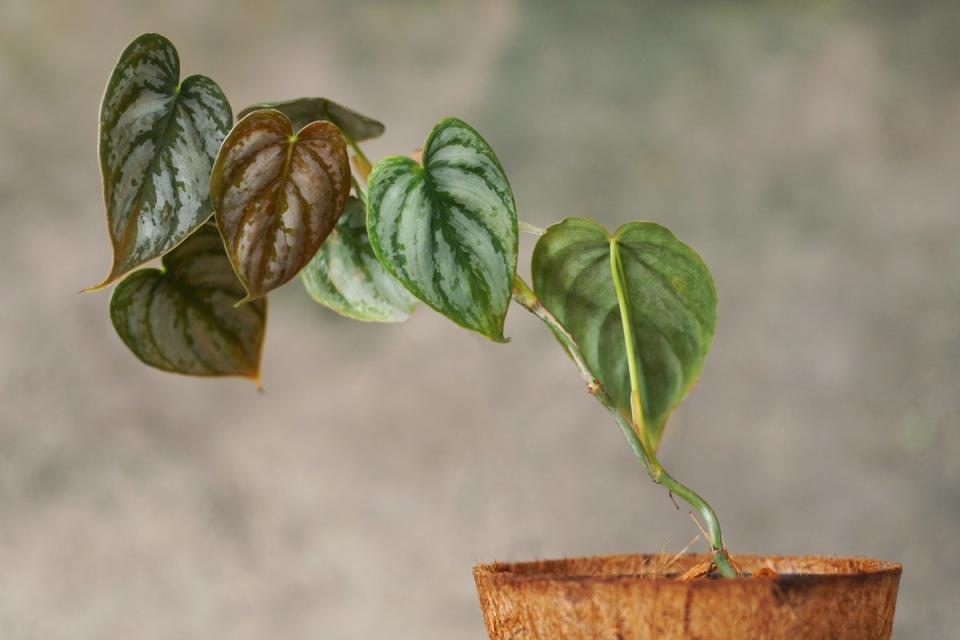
92;33;233;287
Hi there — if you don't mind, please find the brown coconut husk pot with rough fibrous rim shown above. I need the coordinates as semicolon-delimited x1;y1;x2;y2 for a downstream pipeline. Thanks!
473;554;901;640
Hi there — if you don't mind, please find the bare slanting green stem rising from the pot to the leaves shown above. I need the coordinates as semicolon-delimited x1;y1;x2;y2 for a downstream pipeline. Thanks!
513;276;737;578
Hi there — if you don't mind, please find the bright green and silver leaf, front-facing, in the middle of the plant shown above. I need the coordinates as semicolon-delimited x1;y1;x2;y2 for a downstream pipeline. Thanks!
367;118;517;342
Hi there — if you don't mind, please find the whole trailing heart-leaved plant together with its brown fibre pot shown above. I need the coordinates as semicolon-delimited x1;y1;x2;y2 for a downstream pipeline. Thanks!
91;34;901;639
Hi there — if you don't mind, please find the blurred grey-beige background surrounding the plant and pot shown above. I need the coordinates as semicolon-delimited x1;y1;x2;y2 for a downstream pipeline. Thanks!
0;0;960;640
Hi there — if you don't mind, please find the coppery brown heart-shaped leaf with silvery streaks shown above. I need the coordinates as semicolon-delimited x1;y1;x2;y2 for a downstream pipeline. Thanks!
210;109;350;301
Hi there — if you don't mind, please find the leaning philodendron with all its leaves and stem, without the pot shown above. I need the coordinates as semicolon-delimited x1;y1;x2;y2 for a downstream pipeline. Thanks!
91;34;737;577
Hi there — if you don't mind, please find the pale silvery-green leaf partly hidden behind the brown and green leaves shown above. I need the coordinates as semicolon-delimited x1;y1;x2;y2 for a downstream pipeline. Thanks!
300;196;415;322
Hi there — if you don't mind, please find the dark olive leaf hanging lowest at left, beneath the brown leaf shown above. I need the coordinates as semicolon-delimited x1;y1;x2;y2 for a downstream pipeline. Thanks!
110;224;267;379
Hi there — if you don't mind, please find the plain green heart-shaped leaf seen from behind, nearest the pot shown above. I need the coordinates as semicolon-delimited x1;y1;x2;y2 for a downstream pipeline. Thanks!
533;218;717;446
